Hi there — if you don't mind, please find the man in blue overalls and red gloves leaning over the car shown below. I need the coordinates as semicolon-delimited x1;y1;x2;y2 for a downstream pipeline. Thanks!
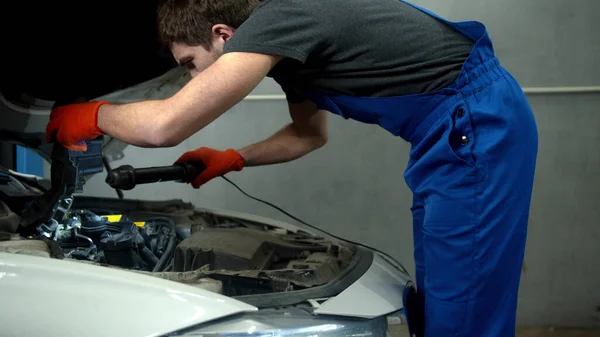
47;0;538;337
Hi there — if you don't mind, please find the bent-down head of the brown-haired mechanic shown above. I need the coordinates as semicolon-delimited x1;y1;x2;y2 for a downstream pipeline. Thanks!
157;0;261;76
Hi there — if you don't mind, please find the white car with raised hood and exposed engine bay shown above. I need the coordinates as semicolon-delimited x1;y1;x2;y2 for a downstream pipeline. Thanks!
0;5;422;337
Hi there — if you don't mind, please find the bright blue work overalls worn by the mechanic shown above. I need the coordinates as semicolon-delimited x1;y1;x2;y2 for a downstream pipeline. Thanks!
305;4;538;337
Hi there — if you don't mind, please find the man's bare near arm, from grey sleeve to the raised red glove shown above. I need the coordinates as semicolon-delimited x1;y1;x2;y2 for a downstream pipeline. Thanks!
98;53;281;147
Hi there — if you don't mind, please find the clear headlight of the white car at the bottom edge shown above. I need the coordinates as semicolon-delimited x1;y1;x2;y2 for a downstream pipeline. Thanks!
170;308;387;337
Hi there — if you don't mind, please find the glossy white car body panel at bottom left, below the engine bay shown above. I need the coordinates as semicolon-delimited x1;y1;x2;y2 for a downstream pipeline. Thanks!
0;253;257;337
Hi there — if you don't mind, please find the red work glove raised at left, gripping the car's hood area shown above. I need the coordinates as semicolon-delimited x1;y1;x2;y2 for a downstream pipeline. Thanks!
46;101;110;151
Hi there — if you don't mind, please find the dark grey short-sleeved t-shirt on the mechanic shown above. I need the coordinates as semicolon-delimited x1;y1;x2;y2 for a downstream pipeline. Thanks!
224;0;474;102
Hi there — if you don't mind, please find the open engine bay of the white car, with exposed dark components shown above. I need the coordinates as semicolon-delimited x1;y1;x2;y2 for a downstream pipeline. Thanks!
0;140;360;297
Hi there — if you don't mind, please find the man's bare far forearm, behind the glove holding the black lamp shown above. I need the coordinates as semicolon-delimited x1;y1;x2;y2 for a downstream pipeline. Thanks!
239;101;327;166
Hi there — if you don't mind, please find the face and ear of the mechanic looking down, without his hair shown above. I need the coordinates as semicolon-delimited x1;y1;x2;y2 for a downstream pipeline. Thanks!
171;25;234;77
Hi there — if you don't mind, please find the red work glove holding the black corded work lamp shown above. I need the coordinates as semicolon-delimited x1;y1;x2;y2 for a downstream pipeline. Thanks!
176;147;244;188
